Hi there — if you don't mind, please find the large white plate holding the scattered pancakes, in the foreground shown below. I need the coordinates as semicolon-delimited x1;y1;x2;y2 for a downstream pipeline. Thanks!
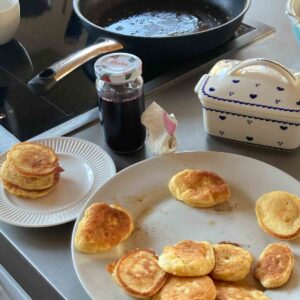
72;152;300;300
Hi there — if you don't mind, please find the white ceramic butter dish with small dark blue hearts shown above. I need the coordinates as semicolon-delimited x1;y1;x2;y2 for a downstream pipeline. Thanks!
195;58;300;150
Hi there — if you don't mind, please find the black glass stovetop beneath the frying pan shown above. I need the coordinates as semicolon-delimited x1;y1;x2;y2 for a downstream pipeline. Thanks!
0;0;272;148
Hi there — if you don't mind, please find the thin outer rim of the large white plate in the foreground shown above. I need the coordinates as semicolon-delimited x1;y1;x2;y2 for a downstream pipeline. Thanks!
70;150;299;299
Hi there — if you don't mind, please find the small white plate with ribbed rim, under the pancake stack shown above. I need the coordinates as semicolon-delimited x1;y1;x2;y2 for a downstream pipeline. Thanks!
0;137;116;227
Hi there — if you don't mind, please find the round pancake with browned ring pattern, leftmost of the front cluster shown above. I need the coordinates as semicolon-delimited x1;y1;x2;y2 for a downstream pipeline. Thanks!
113;249;168;299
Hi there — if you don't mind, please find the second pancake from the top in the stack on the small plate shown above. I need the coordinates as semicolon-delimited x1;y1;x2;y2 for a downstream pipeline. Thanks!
0;160;56;190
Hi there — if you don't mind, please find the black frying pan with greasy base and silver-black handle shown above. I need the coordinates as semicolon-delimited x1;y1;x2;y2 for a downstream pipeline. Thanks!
28;0;250;93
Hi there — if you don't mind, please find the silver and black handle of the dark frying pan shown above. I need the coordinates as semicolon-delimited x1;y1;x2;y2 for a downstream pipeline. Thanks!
28;39;124;95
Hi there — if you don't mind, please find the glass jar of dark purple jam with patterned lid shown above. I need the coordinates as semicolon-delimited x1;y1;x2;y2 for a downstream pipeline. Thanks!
95;53;146;153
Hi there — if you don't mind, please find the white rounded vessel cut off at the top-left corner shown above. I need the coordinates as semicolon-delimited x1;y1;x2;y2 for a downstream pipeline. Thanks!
0;0;20;45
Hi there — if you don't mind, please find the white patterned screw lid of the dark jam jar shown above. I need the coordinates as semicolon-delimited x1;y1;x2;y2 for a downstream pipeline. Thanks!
94;52;142;84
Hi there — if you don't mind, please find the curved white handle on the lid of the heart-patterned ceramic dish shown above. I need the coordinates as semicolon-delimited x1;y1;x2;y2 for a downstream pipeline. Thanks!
227;58;297;86
